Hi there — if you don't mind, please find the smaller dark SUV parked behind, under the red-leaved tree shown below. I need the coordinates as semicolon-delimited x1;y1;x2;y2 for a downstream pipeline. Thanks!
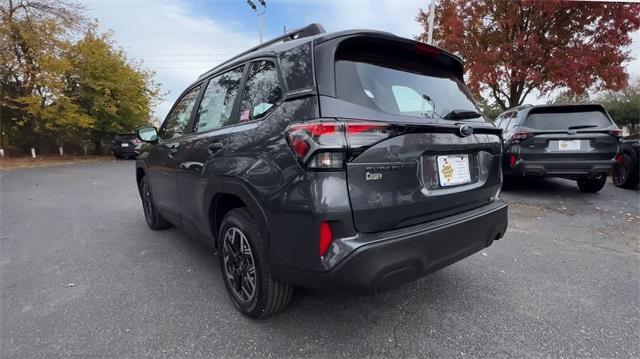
495;104;621;193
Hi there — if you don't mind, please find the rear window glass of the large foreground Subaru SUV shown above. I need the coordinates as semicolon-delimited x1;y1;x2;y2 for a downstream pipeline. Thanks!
335;54;485;121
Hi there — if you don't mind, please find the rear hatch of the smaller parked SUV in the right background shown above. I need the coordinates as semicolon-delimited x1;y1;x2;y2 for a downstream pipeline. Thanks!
516;104;620;161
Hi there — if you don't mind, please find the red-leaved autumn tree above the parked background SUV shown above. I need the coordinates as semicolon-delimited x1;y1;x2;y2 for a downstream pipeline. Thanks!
417;0;640;109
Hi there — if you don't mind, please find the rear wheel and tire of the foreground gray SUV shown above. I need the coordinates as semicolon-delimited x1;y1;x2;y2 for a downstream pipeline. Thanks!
218;208;293;318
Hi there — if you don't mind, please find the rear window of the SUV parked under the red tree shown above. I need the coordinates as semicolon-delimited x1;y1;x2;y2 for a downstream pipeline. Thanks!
523;107;611;131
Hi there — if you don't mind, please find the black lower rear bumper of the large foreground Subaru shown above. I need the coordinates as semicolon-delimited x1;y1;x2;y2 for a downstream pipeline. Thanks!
273;200;508;294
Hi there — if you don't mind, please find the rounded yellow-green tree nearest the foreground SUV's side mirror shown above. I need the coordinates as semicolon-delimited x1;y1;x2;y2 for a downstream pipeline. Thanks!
65;24;159;153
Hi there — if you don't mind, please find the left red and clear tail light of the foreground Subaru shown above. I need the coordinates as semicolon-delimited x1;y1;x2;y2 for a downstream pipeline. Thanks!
286;120;392;170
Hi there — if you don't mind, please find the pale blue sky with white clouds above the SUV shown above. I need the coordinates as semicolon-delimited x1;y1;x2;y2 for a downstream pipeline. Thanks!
81;0;640;120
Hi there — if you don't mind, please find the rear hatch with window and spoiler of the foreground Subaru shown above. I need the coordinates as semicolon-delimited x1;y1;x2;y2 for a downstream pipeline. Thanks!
316;35;502;232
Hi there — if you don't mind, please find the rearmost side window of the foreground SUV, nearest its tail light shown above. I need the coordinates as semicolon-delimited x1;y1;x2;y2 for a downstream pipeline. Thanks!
240;60;282;122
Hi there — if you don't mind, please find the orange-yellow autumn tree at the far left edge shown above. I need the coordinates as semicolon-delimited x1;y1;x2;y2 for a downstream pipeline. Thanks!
0;0;90;152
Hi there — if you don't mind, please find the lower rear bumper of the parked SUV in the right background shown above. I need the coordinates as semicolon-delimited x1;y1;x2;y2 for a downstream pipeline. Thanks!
504;159;616;177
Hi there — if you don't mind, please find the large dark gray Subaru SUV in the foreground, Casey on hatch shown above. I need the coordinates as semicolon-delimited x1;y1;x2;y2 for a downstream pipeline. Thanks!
136;24;507;317
